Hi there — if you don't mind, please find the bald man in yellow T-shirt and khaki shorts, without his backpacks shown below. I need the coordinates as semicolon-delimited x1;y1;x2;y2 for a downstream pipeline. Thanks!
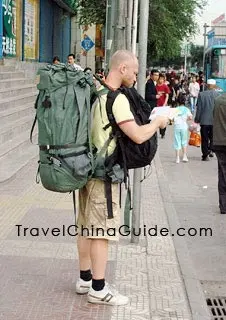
76;50;168;305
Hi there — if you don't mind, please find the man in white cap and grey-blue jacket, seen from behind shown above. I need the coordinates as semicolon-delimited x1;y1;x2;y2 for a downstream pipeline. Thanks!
195;79;219;161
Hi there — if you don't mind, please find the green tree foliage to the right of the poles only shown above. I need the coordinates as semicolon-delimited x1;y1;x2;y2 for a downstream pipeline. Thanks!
148;0;206;60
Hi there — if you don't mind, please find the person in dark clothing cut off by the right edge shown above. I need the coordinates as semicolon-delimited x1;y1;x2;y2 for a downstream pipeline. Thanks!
213;94;226;214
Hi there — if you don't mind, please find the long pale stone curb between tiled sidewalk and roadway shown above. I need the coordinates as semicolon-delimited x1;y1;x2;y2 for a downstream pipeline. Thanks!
154;153;211;320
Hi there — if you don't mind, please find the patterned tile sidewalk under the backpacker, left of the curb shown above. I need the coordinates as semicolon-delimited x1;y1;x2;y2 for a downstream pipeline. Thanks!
0;143;209;320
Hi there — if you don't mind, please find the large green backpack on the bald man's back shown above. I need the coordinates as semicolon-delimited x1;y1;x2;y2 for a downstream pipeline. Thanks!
31;64;94;192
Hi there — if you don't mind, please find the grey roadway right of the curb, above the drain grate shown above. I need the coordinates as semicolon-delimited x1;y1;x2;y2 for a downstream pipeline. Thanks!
159;128;226;282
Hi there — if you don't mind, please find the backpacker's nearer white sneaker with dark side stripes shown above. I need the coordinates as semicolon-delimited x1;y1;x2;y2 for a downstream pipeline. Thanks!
87;284;129;306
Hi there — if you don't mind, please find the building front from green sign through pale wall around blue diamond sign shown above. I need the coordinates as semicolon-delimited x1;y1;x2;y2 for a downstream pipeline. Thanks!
0;0;104;71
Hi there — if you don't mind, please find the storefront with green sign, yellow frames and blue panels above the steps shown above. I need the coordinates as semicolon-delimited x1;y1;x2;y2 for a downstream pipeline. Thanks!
0;0;75;62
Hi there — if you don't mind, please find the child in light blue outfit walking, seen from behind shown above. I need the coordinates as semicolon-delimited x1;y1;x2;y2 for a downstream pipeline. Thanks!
174;93;192;163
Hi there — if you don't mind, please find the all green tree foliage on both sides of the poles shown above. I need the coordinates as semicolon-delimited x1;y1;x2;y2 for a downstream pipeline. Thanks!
75;0;206;63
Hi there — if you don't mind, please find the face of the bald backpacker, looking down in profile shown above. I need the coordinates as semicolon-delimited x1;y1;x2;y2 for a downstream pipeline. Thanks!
120;59;139;88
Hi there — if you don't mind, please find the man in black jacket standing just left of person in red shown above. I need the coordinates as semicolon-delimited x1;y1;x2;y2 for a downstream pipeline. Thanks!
145;69;160;109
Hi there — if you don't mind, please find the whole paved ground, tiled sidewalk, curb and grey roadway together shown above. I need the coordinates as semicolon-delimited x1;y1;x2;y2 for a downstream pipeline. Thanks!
0;126;226;320
